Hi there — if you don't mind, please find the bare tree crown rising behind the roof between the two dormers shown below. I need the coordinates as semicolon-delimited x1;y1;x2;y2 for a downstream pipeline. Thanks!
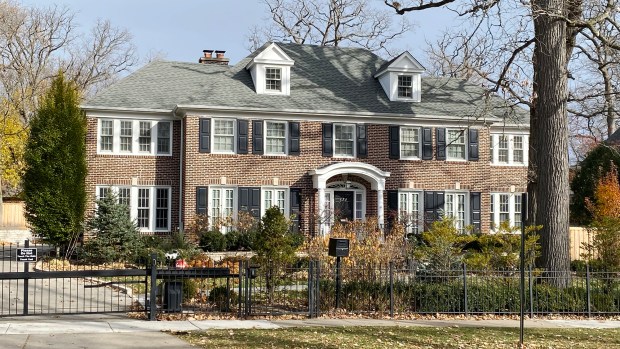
249;0;410;56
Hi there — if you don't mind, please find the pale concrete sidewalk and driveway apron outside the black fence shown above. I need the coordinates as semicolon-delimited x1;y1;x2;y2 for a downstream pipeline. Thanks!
0;315;620;349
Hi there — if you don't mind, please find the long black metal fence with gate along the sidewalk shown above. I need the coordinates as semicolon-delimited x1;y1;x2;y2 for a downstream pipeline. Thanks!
0;239;620;319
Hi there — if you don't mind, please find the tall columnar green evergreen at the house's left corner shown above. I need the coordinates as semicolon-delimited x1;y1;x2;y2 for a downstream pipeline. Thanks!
23;73;86;246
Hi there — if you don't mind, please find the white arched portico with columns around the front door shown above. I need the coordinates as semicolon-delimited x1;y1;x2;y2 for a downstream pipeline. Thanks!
309;162;390;233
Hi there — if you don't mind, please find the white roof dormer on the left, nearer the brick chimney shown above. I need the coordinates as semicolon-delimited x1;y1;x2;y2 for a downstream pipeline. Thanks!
245;43;295;96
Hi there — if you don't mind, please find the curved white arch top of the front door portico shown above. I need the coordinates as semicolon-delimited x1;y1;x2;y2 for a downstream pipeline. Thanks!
308;162;390;190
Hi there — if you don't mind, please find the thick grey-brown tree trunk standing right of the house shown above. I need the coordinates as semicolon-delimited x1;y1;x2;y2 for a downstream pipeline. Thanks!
532;0;570;287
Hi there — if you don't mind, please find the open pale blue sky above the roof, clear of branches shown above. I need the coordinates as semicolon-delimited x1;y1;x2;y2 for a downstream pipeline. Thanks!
19;0;453;64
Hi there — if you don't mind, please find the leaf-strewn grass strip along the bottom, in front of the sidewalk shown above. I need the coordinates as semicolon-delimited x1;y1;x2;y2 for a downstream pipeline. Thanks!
177;327;620;349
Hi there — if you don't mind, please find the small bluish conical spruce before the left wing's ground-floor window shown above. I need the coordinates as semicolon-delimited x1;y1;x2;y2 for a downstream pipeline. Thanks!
82;190;143;263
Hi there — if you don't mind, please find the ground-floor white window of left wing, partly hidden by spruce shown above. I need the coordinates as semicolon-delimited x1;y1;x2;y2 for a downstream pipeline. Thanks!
96;185;172;232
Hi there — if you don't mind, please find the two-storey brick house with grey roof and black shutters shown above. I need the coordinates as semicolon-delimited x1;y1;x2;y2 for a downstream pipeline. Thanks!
83;43;529;233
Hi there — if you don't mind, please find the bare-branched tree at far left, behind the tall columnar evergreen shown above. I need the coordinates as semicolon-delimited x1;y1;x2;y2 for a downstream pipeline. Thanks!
0;0;136;223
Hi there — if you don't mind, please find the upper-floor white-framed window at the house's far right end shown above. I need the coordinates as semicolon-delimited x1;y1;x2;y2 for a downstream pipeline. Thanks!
491;133;528;166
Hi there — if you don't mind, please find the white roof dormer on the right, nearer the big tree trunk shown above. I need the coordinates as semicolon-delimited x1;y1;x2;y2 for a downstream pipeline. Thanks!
375;51;426;102
